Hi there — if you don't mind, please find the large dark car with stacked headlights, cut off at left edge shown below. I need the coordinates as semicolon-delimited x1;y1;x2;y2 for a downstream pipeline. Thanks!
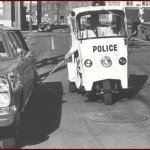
0;27;37;148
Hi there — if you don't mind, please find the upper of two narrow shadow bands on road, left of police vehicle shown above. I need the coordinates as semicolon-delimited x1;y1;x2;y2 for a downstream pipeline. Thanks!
37;55;64;69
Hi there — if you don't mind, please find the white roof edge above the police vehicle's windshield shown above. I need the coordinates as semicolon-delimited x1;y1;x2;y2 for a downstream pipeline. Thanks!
71;6;124;16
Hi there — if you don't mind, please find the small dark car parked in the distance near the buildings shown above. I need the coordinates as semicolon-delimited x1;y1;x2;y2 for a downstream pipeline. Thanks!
38;22;53;32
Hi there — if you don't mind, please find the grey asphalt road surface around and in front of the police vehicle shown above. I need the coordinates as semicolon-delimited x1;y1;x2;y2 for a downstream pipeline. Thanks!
20;28;150;148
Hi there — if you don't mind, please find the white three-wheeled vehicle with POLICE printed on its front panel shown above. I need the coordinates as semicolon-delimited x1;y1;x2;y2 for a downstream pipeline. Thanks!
67;6;134;105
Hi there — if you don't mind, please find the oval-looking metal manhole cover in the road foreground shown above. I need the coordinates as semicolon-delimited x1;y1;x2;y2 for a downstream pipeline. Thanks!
89;112;148;123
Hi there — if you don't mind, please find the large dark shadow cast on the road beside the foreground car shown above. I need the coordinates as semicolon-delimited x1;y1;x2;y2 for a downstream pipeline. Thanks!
19;82;63;148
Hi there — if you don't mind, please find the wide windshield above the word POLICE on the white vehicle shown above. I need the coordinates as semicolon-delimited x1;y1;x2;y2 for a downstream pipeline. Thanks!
77;10;126;39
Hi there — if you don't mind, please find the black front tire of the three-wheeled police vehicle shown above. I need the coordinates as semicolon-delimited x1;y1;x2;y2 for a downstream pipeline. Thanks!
103;80;113;105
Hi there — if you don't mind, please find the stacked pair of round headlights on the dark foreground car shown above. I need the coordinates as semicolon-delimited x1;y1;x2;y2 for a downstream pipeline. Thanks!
0;78;10;107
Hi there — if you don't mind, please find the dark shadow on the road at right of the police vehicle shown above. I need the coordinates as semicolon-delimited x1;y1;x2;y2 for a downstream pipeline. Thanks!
116;74;148;102
